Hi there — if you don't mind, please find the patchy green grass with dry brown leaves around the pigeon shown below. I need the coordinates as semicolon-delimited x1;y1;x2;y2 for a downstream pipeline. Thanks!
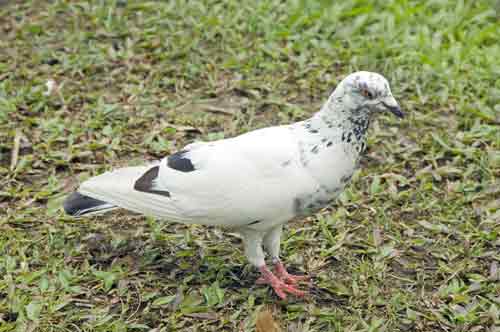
0;0;500;332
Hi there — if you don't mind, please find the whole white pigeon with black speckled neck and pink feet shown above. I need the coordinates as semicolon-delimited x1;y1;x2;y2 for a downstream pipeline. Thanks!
63;71;404;299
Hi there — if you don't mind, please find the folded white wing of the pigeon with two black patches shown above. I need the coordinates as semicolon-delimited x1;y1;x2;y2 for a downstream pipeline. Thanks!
79;126;315;227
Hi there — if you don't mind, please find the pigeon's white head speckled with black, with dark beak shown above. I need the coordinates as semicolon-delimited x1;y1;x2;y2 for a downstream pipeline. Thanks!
335;71;404;118
